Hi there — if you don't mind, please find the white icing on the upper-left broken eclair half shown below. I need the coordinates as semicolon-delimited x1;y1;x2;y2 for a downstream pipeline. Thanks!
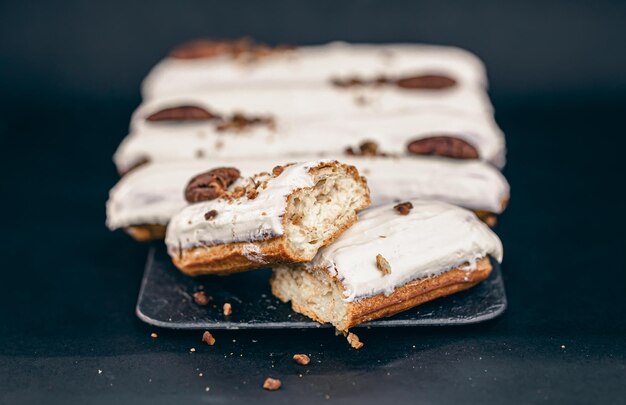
165;160;324;254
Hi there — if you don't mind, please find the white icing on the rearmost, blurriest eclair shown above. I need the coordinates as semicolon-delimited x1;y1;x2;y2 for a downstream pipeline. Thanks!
142;42;487;98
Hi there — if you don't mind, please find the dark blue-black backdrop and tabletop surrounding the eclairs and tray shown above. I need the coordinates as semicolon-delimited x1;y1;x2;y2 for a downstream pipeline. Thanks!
0;0;626;404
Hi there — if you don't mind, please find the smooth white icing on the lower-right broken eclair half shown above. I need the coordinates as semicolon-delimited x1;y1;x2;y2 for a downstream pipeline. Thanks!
296;200;502;301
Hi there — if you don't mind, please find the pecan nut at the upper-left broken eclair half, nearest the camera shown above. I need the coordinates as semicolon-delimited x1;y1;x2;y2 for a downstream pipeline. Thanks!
185;167;240;203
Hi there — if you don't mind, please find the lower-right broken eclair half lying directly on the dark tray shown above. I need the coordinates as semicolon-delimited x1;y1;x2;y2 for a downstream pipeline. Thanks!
270;200;502;331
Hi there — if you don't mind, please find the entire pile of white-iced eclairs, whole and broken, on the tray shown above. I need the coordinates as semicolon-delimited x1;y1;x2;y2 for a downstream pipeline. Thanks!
107;39;509;333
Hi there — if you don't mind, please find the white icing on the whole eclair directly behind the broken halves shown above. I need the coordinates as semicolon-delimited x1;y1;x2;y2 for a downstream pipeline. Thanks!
107;155;509;229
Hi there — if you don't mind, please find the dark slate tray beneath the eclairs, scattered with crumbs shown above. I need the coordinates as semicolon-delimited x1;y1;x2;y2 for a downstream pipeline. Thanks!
136;246;507;329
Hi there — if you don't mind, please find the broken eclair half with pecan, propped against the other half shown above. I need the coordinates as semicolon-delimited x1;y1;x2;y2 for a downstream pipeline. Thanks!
165;160;370;275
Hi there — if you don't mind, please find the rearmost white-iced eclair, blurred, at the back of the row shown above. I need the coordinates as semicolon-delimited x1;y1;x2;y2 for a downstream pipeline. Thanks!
142;39;487;98
